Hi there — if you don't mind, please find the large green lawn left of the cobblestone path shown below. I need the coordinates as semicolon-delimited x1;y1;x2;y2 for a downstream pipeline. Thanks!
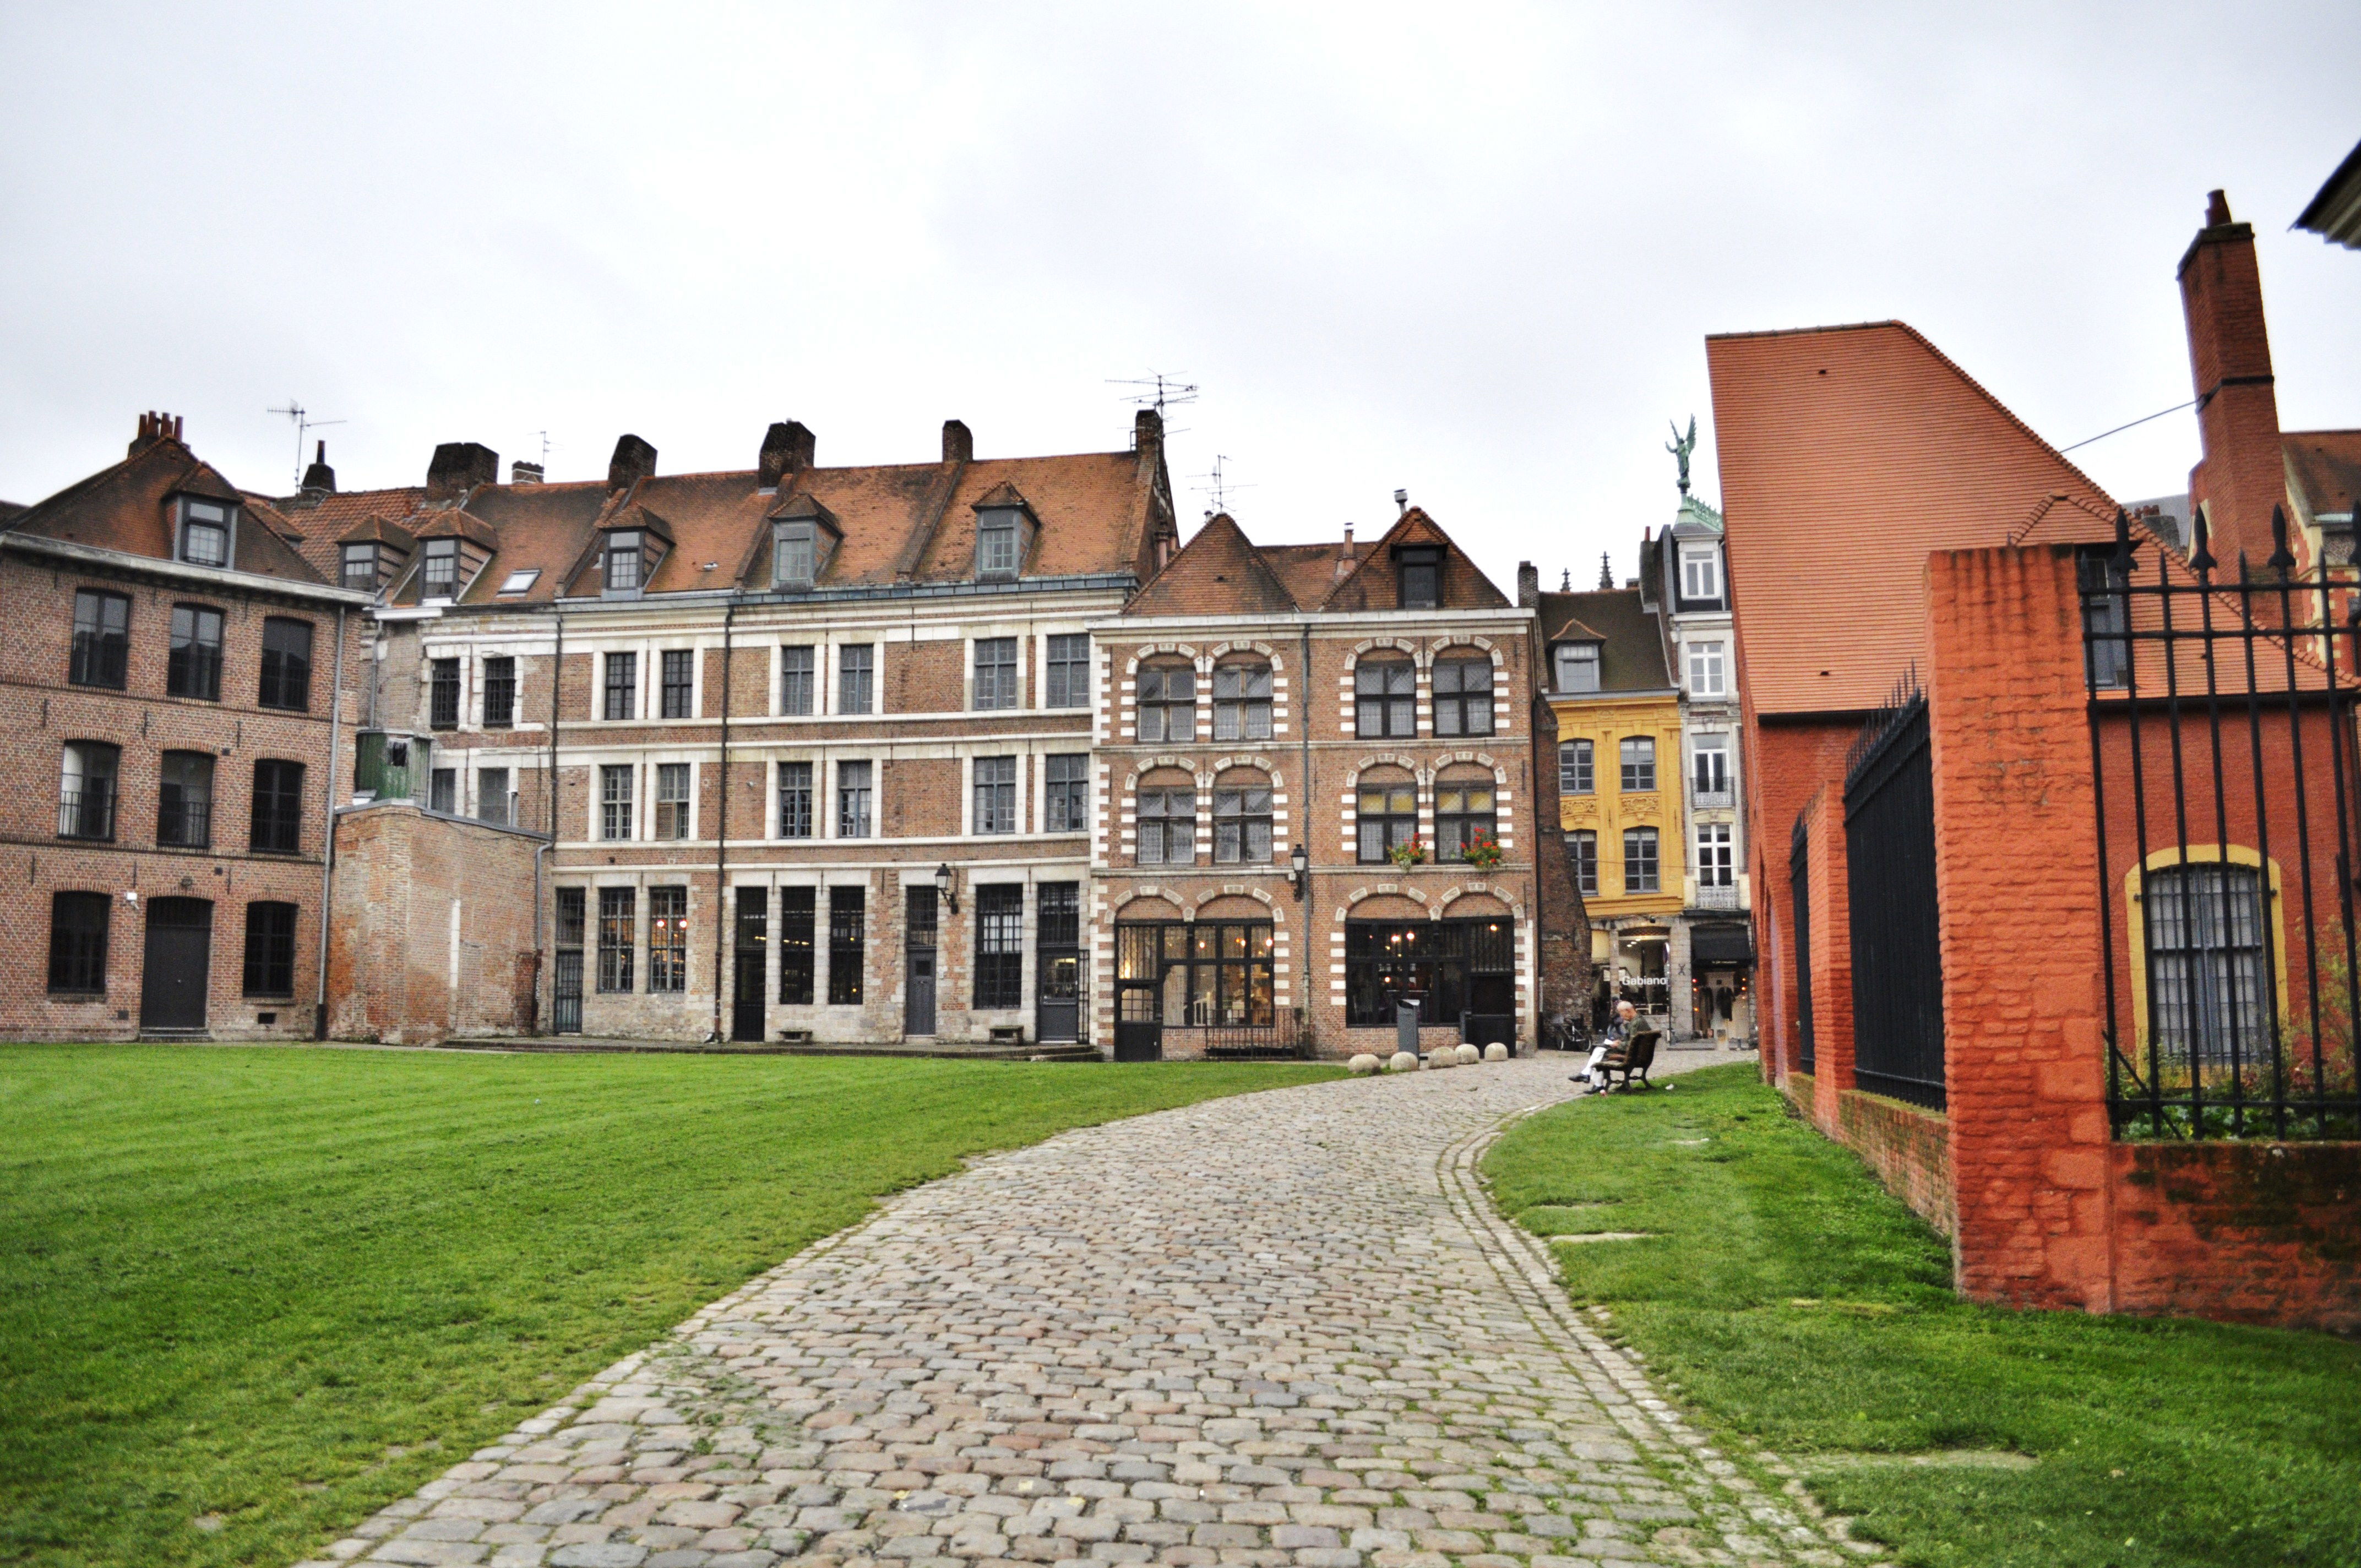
0;1046;1334;1566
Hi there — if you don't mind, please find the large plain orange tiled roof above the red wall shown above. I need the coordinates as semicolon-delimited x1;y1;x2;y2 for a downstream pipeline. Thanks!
1705;321;2115;713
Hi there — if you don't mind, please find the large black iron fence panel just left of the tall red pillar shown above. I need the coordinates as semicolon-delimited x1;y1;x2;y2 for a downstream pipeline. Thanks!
1844;676;1943;1110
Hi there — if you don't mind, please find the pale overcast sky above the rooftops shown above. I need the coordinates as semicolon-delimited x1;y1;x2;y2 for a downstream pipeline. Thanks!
0;0;2361;586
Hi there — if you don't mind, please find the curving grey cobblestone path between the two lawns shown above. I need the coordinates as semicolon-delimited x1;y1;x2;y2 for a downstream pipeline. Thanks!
309;1060;1868;1568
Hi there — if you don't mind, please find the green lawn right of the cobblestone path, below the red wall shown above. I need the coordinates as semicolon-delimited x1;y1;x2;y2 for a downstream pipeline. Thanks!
1485;1065;2361;1568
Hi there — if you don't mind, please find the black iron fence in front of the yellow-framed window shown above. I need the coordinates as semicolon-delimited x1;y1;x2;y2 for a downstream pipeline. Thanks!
2080;510;2361;1138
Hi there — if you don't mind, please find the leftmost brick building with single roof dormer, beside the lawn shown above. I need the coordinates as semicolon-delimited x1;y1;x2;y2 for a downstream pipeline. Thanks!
0;413;368;1039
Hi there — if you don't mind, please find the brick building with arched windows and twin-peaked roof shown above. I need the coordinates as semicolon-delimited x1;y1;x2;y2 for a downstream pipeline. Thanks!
1091;508;1587;1058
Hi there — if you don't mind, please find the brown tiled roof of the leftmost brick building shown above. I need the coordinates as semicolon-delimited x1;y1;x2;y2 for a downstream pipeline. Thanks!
7;434;328;586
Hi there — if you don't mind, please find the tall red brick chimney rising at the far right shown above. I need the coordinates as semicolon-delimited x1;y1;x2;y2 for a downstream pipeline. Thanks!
2179;191;2288;567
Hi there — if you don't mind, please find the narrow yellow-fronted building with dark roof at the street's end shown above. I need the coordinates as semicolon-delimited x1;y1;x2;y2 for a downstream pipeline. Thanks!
1542;588;1688;1015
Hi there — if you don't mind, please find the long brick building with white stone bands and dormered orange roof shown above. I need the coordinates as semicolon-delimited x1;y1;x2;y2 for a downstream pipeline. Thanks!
286;413;1176;1042
